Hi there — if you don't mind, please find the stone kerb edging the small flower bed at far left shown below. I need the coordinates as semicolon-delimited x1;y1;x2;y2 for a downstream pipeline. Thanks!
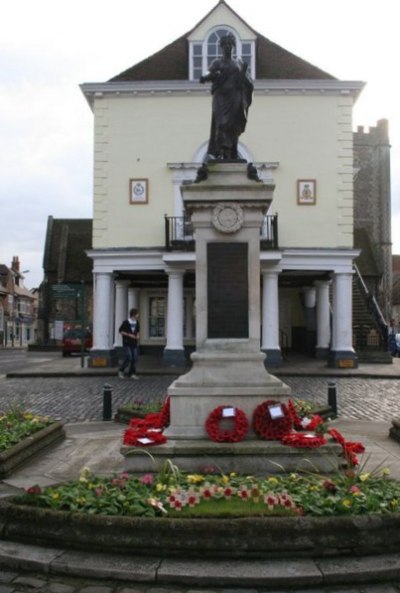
0;421;65;480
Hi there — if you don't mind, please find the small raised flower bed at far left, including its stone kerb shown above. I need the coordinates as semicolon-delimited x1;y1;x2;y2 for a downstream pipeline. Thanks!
0;410;65;479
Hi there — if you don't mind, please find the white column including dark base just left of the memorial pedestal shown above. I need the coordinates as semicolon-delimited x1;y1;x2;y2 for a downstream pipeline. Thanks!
163;270;186;366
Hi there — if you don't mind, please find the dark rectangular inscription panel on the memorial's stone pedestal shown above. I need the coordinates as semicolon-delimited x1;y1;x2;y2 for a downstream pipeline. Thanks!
207;242;249;339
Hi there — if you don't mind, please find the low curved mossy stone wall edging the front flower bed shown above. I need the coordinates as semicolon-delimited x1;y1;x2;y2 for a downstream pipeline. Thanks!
0;498;400;559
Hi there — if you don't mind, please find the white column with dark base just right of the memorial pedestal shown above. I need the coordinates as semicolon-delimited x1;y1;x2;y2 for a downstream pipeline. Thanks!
261;270;283;367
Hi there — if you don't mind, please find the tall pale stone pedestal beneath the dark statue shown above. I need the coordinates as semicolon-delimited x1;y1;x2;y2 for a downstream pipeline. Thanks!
165;163;290;439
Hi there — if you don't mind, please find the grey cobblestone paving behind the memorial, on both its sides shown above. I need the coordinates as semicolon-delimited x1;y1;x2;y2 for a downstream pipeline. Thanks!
0;375;400;424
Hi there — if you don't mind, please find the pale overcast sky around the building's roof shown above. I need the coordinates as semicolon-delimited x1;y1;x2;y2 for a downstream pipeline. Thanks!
0;0;400;288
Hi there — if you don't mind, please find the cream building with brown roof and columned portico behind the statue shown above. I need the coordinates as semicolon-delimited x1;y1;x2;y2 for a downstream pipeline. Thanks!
81;0;363;366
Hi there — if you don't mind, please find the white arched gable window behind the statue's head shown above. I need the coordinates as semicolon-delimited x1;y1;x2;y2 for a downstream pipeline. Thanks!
190;27;255;80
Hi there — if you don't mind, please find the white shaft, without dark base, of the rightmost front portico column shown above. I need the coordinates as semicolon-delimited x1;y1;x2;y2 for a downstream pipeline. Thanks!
332;273;354;352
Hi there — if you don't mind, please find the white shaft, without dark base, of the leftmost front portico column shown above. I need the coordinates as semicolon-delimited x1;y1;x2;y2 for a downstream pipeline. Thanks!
93;272;113;350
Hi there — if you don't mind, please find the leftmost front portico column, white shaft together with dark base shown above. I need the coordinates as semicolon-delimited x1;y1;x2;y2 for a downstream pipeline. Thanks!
89;272;116;367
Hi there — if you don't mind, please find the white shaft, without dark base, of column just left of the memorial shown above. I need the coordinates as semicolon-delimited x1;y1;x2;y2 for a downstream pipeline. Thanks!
165;270;185;350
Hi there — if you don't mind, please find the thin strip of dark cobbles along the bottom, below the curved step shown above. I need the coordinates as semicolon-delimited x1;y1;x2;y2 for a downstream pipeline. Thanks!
0;570;400;593
